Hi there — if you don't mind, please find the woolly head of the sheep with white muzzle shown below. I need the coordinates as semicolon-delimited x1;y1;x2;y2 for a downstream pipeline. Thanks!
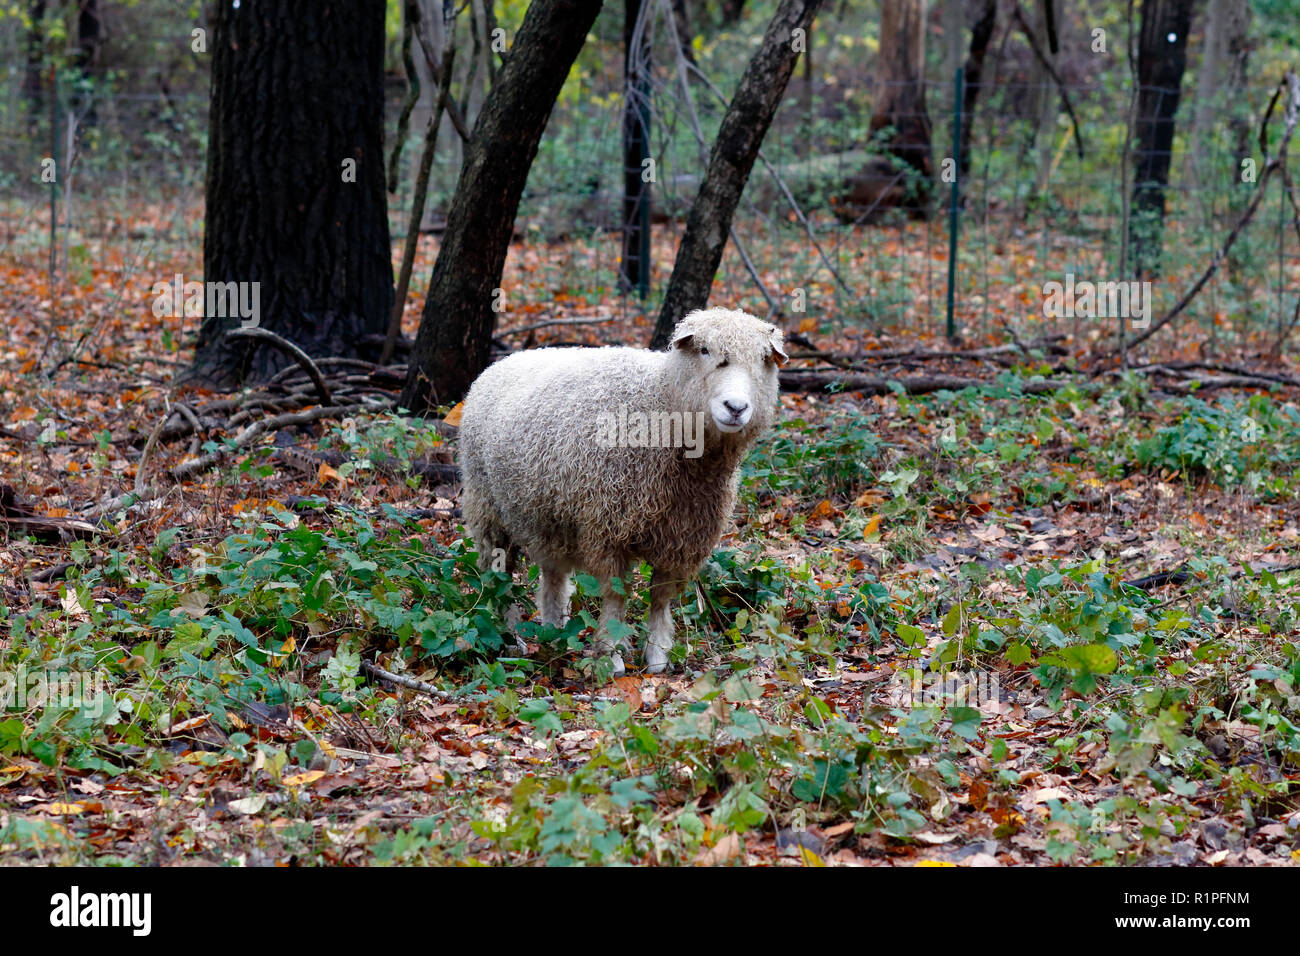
672;308;788;434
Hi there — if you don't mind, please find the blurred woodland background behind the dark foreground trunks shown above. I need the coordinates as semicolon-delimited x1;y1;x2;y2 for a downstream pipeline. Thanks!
0;0;1300;356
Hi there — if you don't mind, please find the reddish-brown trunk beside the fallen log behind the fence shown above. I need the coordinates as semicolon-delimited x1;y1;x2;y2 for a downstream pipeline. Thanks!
871;0;932;212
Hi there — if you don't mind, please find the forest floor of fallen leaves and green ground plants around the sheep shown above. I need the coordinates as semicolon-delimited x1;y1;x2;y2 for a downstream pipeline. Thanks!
0;209;1300;866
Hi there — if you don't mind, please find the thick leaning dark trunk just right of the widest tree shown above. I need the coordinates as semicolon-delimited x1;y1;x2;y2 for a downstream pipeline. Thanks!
402;0;601;414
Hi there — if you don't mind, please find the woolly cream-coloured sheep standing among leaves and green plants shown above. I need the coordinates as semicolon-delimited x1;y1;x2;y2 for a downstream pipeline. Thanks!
459;308;787;675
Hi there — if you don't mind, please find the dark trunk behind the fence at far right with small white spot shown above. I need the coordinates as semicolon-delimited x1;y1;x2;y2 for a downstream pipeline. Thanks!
1128;0;1193;278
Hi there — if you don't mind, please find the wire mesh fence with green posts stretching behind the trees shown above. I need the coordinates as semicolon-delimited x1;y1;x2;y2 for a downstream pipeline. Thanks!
0;5;1300;356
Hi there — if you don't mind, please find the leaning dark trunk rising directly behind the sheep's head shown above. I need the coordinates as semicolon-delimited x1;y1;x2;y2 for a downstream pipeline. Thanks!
650;0;822;349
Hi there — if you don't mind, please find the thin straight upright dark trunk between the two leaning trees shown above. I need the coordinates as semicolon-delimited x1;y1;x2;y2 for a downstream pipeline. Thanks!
619;0;650;299
